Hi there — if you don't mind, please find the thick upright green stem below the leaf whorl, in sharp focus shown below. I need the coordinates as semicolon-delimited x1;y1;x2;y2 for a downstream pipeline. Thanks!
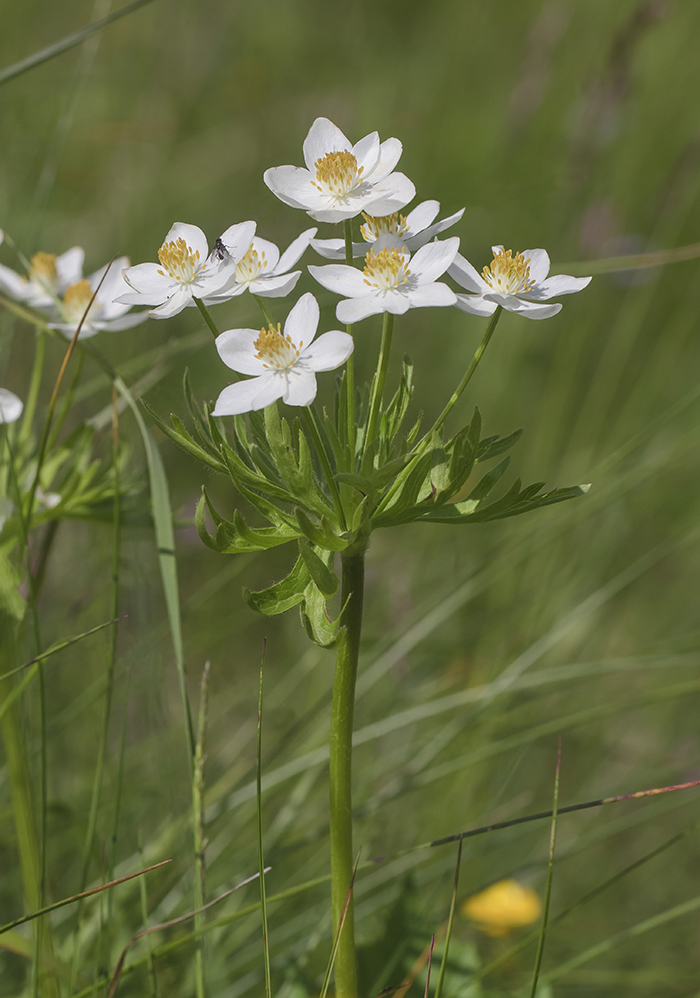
330;543;365;998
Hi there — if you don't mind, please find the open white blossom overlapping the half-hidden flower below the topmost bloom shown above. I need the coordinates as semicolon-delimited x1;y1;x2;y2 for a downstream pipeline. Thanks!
309;236;459;323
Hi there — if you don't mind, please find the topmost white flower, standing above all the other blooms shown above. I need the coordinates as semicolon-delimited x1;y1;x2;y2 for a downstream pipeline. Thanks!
263;118;416;222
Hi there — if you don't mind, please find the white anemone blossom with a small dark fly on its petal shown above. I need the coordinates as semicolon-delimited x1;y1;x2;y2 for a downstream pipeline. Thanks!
116;222;255;319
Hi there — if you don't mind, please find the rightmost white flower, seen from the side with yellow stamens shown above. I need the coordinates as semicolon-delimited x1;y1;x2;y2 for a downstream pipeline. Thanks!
448;246;591;319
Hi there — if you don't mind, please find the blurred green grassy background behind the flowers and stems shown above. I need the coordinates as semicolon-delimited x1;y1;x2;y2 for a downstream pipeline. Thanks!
0;0;700;998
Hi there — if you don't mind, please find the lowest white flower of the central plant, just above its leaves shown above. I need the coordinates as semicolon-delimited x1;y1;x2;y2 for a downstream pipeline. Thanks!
212;293;354;416
